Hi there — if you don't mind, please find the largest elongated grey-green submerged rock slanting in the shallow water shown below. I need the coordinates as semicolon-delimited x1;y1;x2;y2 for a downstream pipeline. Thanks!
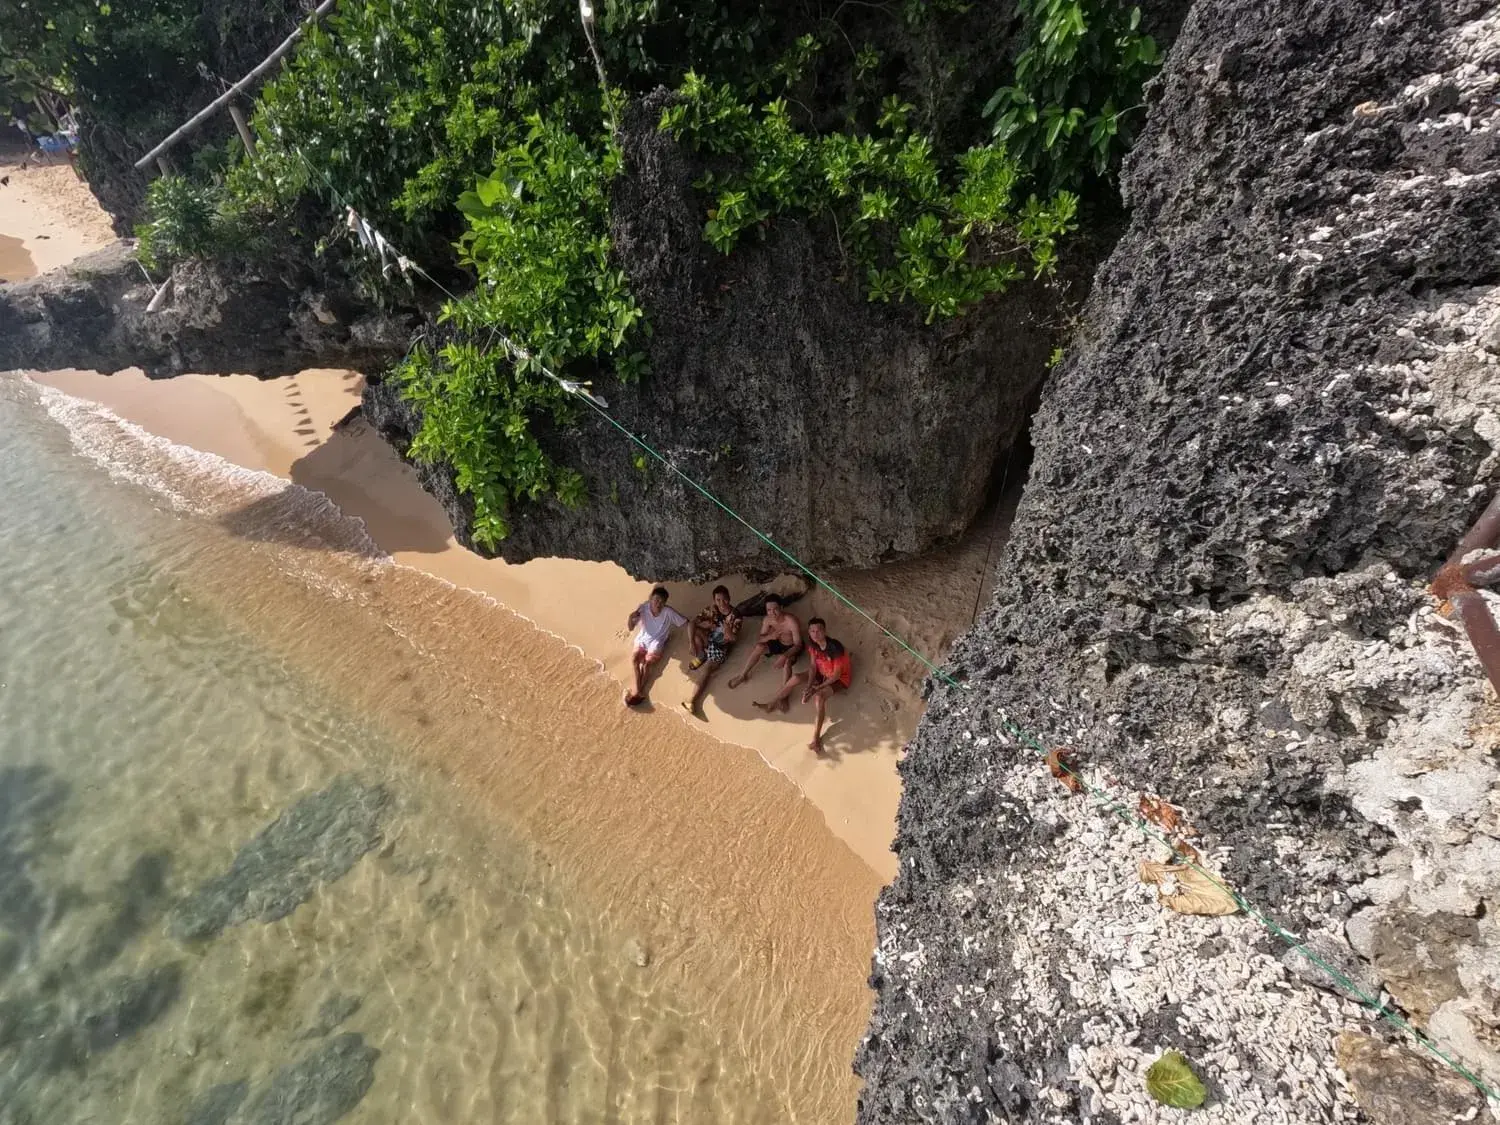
168;777;389;941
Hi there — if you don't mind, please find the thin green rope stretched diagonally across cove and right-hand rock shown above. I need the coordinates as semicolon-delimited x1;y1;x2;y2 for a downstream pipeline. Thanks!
243;105;1500;1103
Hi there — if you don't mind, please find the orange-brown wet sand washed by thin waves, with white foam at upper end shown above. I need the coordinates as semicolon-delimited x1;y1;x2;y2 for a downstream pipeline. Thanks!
23;375;882;1122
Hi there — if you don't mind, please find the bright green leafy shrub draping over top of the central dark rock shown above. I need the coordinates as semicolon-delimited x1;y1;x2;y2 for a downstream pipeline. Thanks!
662;74;1077;321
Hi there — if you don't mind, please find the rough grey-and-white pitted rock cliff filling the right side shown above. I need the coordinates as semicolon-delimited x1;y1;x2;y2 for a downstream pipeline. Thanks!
857;0;1500;1125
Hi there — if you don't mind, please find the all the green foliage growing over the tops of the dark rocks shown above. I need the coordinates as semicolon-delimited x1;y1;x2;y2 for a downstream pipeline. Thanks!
41;0;1155;546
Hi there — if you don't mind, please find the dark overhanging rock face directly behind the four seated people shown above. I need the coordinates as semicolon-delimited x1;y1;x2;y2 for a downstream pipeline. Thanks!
366;92;1104;579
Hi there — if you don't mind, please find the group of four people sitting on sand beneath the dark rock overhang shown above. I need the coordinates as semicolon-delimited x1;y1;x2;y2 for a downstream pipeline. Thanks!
626;587;854;753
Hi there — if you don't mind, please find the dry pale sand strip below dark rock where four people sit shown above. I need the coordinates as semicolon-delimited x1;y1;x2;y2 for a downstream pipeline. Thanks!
36;371;1005;879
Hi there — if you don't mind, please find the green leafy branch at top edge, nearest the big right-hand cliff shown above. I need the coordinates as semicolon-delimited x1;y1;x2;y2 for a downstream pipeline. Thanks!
984;0;1161;188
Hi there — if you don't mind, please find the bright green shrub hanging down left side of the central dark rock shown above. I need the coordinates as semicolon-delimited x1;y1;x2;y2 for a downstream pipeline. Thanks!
399;116;647;548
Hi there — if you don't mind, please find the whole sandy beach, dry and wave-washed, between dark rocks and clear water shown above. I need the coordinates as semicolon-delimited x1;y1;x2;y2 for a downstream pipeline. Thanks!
0;154;1014;1121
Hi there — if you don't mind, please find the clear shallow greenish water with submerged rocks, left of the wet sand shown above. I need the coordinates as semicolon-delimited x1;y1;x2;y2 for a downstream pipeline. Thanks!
0;377;786;1125
